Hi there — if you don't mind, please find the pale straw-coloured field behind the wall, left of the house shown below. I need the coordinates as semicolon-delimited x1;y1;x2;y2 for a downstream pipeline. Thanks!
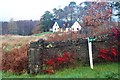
0;32;50;52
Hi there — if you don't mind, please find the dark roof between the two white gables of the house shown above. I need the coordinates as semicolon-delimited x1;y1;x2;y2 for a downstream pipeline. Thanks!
54;20;76;28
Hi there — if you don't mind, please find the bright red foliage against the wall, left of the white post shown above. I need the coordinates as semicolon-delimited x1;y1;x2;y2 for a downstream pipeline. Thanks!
43;52;75;74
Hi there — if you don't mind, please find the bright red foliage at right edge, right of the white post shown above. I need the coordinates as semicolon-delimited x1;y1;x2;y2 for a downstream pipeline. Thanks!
98;28;120;61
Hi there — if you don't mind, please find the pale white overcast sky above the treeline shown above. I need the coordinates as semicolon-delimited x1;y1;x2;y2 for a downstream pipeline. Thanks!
0;0;86;21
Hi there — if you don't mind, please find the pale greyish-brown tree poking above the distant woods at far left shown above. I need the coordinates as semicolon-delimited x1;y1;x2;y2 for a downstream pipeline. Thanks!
8;18;19;34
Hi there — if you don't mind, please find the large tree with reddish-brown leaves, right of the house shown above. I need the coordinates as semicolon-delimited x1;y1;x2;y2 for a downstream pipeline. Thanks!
80;2;112;34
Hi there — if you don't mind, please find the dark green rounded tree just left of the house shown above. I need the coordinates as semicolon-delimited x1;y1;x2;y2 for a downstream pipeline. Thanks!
40;11;53;31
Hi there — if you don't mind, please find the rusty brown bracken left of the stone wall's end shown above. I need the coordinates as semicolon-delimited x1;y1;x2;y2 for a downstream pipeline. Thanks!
2;45;28;73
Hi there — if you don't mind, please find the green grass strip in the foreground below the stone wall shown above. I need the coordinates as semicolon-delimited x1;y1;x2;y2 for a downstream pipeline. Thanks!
1;63;120;78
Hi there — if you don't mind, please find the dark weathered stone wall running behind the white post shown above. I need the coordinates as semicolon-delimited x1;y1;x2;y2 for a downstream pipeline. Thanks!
28;35;116;73
